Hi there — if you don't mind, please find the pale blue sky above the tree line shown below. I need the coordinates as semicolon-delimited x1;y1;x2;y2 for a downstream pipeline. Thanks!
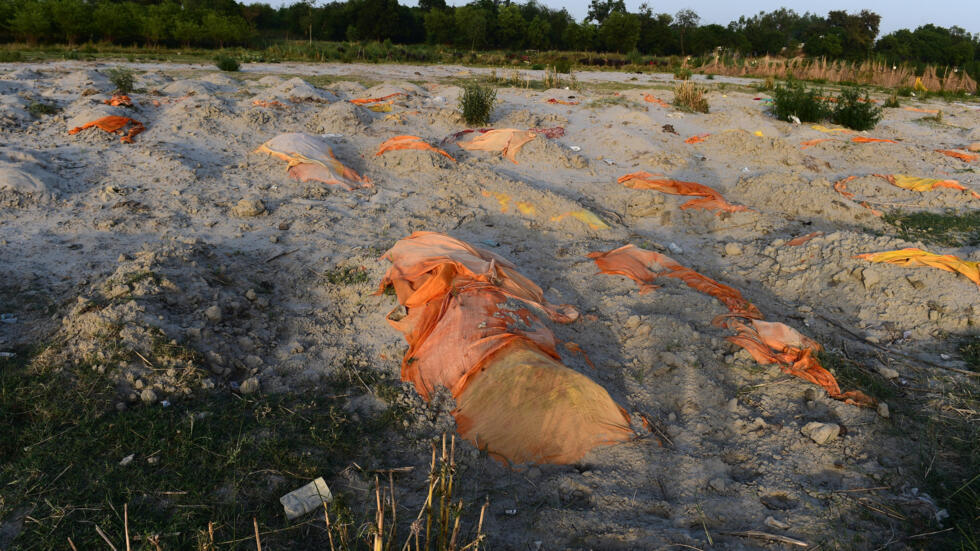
386;0;980;36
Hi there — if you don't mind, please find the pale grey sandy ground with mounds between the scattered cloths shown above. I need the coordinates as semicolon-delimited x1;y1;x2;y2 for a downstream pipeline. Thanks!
0;62;980;549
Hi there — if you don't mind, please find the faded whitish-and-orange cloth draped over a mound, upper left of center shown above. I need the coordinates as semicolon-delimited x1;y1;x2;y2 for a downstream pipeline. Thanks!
255;133;371;190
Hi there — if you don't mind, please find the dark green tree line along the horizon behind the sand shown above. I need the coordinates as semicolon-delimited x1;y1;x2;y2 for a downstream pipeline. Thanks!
0;0;980;74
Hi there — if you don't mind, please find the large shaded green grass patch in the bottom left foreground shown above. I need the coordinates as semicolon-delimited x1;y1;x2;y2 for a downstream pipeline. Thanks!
0;350;399;550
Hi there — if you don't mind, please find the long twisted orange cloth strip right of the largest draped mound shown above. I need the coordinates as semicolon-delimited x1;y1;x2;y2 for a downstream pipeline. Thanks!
588;245;875;406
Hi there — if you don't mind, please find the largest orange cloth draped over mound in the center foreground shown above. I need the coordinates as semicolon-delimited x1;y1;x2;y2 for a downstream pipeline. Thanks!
381;232;635;464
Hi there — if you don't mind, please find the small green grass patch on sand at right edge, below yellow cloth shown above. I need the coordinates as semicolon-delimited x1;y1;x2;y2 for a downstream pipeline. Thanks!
882;210;980;247
